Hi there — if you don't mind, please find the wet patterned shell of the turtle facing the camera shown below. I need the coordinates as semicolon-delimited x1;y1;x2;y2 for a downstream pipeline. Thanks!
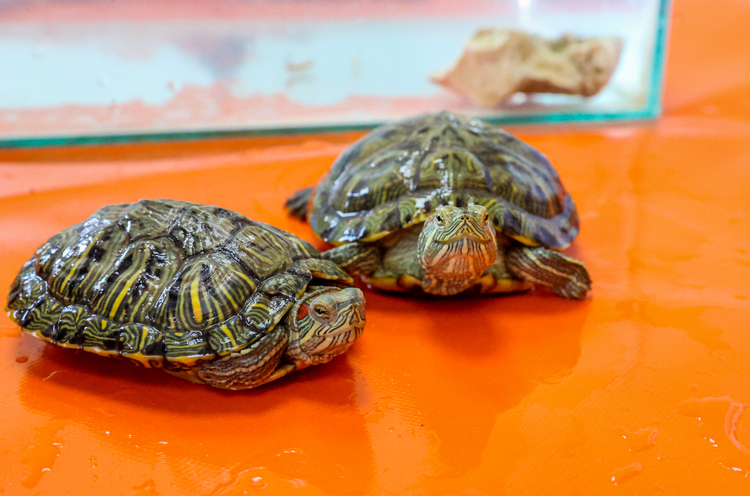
308;112;578;249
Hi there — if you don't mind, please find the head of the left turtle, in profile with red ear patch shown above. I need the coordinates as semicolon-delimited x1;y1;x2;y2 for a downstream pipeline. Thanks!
286;287;365;365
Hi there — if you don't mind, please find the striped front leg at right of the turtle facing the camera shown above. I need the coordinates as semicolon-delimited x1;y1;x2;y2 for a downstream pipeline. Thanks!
506;246;591;300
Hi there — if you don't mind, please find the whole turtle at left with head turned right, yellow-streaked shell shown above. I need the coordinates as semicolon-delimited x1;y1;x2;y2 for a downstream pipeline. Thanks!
7;200;365;389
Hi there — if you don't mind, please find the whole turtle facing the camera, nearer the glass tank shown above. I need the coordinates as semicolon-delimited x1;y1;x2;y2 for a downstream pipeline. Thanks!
287;112;591;299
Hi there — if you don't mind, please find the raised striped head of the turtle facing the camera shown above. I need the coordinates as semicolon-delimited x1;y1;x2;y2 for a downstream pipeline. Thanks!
417;205;497;295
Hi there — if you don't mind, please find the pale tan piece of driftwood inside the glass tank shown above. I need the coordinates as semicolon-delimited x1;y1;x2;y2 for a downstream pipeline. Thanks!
430;29;623;106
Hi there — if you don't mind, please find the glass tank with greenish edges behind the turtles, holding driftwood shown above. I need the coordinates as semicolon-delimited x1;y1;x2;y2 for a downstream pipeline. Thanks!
0;0;669;147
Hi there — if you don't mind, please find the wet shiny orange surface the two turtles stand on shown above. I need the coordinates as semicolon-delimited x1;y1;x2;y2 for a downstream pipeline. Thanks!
0;0;750;496
